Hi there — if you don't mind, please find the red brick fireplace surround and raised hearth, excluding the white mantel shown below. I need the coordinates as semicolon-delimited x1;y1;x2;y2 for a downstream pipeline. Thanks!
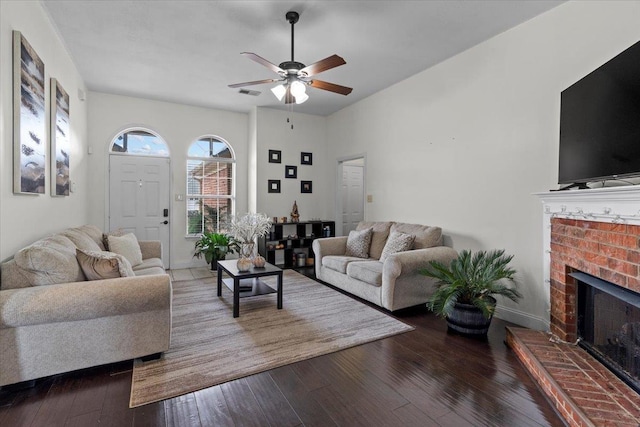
507;217;640;427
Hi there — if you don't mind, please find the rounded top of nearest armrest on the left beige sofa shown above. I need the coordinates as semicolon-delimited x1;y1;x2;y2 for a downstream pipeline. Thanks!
0;274;172;329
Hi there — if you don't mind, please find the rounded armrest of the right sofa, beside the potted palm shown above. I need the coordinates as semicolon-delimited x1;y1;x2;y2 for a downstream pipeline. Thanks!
381;246;458;311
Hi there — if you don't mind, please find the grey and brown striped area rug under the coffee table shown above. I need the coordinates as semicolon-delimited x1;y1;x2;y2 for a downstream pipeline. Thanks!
129;270;413;408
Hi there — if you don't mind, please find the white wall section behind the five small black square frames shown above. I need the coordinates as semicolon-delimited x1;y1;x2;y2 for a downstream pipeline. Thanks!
256;108;334;221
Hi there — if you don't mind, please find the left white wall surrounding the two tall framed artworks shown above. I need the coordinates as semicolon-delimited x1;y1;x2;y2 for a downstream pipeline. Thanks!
0;0;90;260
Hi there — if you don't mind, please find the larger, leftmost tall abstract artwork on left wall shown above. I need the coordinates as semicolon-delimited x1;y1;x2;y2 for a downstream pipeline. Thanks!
13;31;47;194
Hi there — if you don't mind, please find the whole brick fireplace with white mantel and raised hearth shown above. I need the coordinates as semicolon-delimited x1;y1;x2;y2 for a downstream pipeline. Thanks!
507;186;640;427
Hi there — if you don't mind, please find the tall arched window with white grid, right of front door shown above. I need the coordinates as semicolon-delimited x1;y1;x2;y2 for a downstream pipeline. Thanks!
187;136;235;236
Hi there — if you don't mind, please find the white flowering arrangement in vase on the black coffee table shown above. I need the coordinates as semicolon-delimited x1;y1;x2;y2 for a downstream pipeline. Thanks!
230;213;271;271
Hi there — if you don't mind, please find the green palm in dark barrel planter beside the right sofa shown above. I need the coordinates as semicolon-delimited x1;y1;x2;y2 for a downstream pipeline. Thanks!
419;250;522;336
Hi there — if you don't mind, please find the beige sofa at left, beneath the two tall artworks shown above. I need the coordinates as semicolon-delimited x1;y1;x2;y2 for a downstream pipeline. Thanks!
0;225;171;386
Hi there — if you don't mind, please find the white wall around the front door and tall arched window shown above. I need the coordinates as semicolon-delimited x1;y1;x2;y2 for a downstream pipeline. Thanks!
89;92;249;268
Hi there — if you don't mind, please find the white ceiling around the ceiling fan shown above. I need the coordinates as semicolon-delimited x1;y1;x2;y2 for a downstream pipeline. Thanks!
41;0;562;115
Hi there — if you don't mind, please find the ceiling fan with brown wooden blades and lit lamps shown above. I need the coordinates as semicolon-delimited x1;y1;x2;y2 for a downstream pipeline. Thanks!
229;11;353;104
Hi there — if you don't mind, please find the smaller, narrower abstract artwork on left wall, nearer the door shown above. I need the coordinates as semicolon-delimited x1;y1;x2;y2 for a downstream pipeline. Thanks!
49;79;71;196
